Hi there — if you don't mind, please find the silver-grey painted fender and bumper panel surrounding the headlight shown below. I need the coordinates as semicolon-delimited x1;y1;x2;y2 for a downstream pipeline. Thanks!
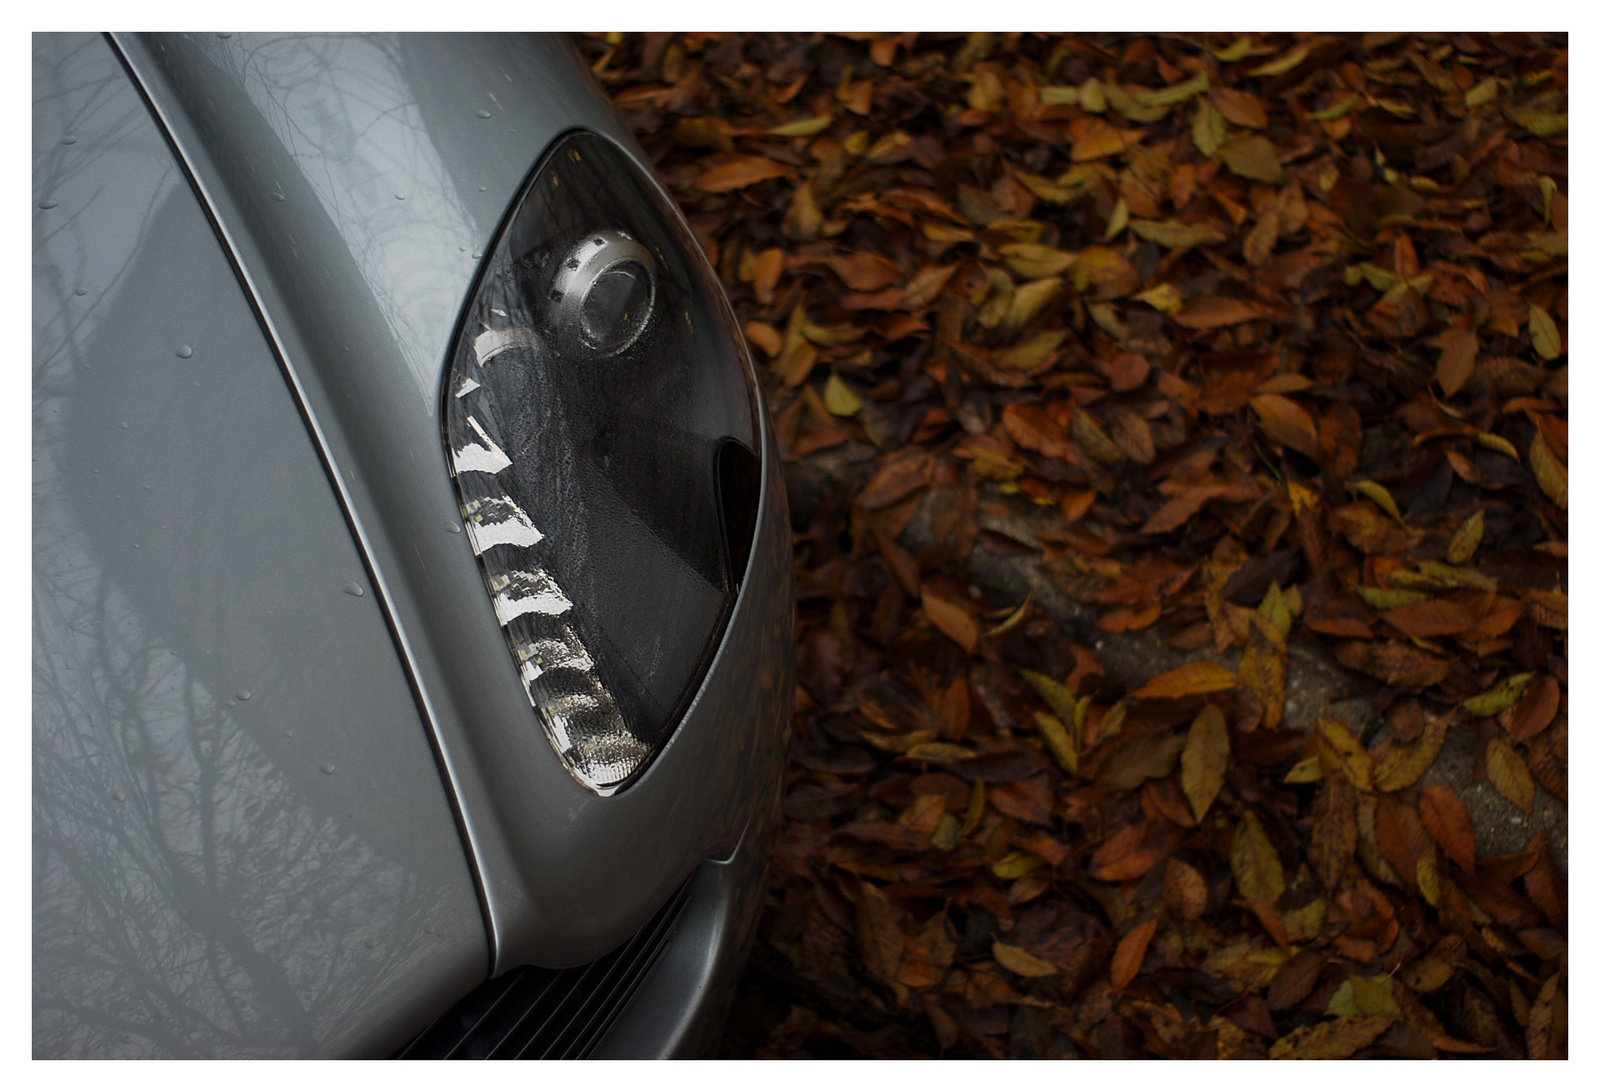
118;35;794;972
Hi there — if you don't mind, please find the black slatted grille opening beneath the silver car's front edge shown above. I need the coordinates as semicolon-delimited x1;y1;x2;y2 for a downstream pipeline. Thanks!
395;882;688;1058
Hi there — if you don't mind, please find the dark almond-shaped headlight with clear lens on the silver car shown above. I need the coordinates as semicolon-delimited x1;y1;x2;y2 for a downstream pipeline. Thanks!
445;131;760;793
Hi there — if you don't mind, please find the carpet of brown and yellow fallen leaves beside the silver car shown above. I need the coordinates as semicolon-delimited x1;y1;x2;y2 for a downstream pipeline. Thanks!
581;34;1568;1057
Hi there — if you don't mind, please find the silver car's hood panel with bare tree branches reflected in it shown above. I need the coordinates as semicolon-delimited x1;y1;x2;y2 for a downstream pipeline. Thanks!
32;35;486;1057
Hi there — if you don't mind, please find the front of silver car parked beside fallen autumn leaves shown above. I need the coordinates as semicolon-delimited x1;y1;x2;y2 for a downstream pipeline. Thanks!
32;34;794;1057
